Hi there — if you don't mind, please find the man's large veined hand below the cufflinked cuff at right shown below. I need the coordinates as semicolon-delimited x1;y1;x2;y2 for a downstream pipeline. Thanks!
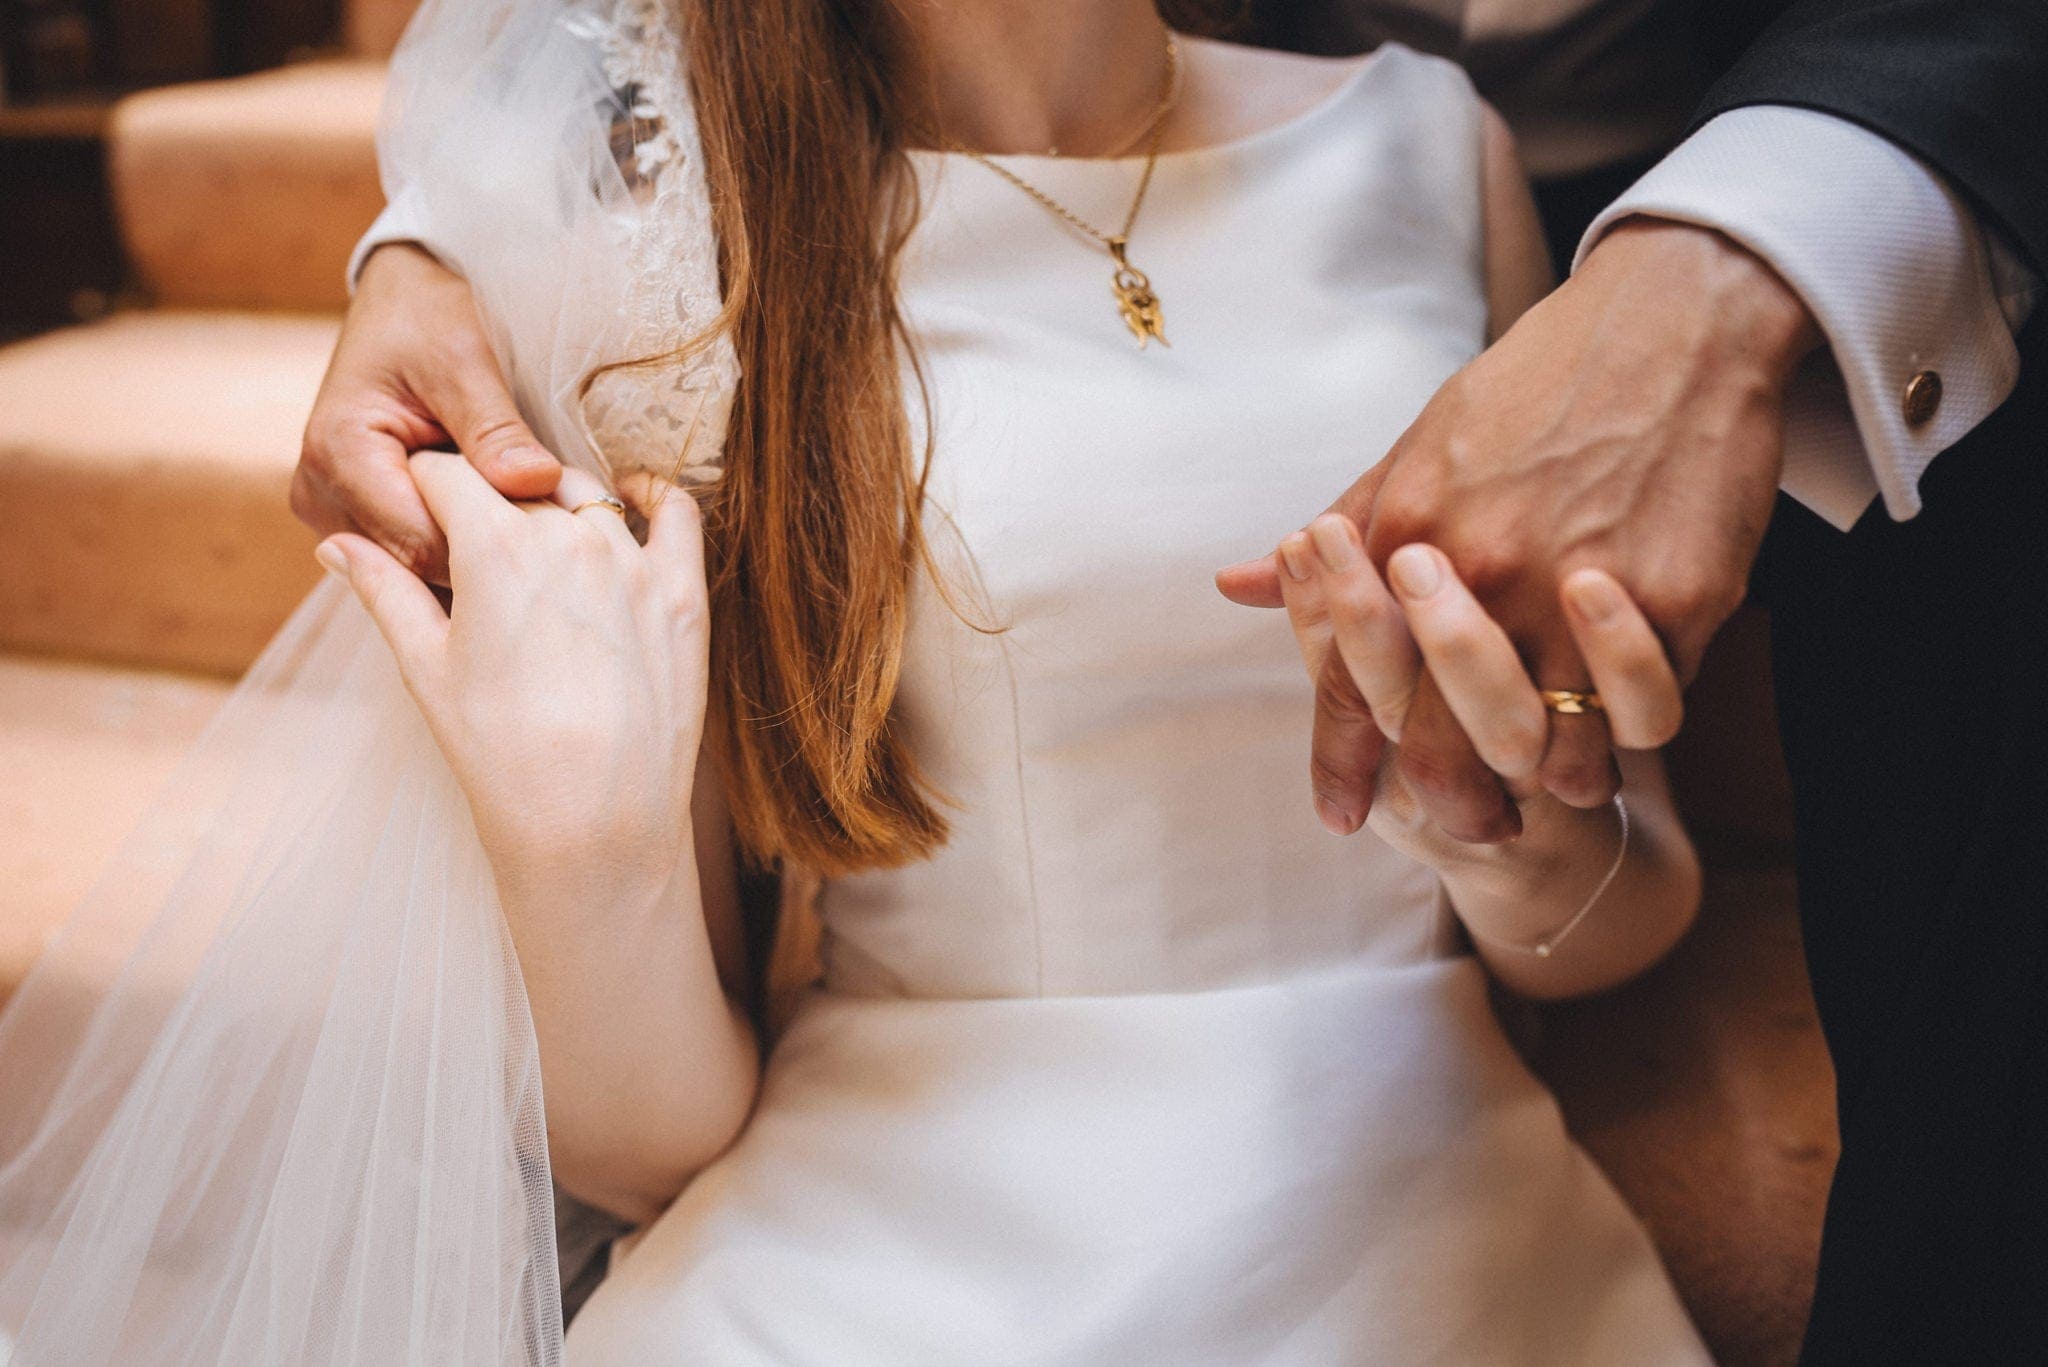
1217;219;1821;842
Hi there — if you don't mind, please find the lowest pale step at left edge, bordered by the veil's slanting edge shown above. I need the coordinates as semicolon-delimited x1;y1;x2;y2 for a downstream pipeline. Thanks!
0;656;229;1016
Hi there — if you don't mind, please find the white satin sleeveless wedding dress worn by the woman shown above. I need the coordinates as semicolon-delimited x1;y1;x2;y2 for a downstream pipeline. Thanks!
569;47;1706;1367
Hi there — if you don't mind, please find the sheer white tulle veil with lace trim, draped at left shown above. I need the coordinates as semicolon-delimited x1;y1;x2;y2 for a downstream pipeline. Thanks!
0;0;735;1367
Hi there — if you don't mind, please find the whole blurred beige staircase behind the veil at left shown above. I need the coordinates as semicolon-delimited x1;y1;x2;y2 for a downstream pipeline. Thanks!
0;0;414;1000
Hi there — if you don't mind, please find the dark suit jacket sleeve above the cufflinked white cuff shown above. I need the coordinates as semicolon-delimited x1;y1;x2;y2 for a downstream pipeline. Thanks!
1696;0;2048;273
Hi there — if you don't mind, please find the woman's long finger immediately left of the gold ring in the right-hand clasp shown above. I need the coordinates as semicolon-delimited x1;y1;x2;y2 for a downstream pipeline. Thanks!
1386;543;1550;783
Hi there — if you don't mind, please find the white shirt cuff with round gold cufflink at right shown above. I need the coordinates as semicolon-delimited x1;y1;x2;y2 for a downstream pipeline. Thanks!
1573;105;2038;531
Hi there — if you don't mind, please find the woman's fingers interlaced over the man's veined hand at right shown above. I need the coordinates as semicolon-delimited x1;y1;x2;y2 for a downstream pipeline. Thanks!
1280;514;1683;869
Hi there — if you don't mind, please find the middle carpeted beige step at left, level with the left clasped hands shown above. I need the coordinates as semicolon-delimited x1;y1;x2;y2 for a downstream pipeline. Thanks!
0;314;336;674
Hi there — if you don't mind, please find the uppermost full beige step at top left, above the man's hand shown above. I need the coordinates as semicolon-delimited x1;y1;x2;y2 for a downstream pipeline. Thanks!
109;59;385;309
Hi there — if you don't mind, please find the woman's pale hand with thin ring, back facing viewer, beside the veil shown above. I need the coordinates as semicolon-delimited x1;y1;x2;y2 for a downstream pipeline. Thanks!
319;451;709;906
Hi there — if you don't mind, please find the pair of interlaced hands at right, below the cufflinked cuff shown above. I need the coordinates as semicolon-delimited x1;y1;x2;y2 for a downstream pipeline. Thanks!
1217;221;1819;846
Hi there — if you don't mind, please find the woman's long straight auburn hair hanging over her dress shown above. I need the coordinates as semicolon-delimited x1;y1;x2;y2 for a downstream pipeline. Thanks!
680;0;1241;875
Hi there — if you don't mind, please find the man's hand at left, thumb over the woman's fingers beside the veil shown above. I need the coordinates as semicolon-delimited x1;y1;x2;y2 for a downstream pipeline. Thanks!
291;242;561;584
